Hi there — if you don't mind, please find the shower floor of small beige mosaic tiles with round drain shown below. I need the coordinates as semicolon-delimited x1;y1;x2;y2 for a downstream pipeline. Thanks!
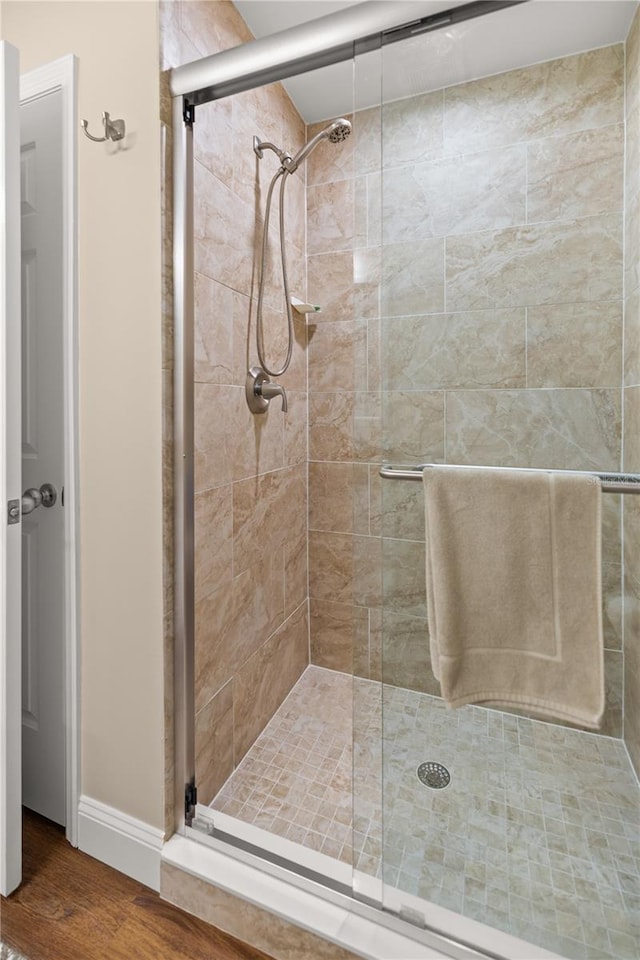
211;666;640;960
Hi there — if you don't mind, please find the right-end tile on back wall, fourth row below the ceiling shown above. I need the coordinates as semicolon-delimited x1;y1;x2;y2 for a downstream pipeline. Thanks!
527;300;622;389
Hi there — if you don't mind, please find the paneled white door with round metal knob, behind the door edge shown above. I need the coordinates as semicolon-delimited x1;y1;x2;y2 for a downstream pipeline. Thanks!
20;89;66;824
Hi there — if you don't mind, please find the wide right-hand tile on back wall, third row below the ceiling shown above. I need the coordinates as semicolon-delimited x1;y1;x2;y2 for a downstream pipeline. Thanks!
446;213;622;310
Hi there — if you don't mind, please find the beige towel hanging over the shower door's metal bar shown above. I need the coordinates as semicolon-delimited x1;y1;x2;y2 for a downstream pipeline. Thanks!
424;466;604;729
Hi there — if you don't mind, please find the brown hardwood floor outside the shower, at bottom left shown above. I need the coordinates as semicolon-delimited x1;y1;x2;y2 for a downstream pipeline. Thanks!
0;810;270;960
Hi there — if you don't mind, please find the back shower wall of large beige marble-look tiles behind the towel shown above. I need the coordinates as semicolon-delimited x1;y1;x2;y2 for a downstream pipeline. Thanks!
307;44;628;744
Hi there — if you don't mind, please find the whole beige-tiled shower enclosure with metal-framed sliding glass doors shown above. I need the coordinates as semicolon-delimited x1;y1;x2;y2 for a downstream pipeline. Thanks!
164;4;640;960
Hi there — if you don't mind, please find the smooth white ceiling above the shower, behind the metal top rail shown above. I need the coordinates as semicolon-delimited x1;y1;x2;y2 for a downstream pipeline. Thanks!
235;0;638;123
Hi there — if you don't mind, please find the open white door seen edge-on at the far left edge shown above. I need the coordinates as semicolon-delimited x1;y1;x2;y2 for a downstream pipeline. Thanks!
0;43;22;896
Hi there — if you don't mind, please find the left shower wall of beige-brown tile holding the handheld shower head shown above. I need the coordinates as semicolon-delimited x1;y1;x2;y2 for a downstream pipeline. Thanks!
160;0;308;803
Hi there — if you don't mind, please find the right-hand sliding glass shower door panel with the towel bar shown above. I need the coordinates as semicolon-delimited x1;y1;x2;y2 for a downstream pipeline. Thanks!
367;12;640;960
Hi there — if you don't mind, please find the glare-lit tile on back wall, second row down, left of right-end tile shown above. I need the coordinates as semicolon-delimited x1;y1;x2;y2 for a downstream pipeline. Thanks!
382;146;526;243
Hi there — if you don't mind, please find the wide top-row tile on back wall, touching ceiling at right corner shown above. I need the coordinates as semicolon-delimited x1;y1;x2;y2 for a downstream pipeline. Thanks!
444;44;624;154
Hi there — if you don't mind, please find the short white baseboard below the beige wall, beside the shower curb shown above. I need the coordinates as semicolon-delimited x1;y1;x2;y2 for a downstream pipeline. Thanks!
78;796;164;891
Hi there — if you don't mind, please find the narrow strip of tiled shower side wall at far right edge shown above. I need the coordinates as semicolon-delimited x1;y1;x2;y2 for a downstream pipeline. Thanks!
623;7;640;776
